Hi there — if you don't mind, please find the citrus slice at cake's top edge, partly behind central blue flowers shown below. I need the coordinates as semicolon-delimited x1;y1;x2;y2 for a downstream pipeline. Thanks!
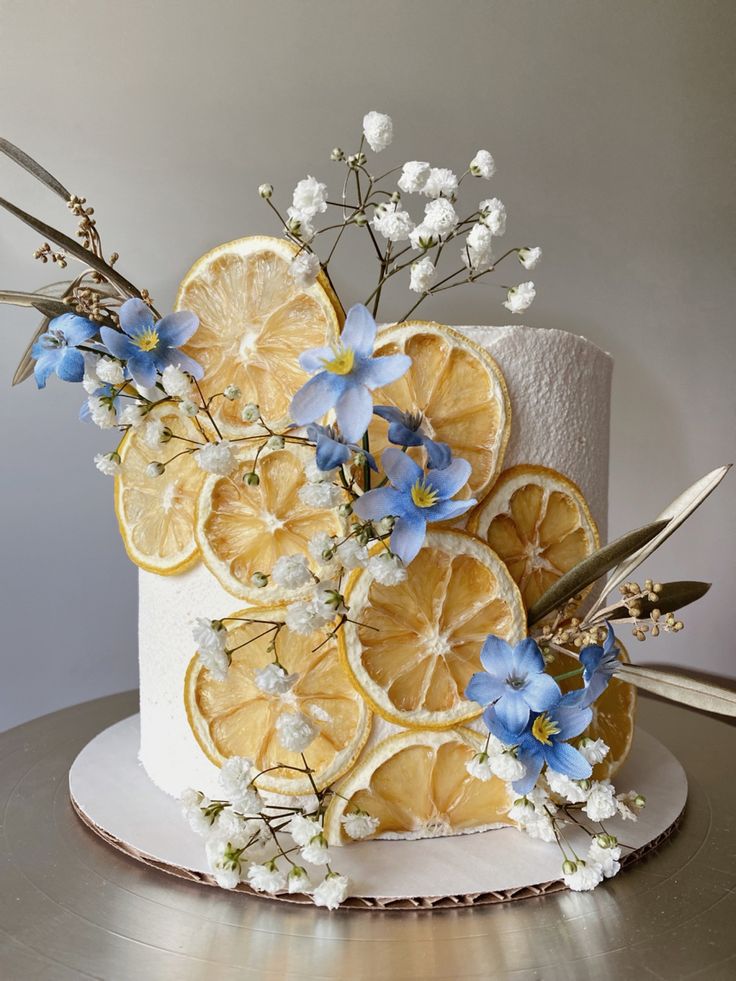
369;321;511;497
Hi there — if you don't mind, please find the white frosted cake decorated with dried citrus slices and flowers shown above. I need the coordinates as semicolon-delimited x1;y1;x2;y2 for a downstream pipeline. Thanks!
10;112;724;909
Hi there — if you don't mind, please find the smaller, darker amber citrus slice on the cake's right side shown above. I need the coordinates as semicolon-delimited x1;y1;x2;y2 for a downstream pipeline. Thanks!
468;464;599;609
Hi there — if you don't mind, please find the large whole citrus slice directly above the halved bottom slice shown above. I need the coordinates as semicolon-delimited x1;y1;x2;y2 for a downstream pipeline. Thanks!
339;530;526;729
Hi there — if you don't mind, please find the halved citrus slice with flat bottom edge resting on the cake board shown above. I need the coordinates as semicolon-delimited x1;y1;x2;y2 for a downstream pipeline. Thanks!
325;729;515;845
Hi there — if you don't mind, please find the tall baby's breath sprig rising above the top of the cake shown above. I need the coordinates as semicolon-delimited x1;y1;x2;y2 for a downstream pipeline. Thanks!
258;112;542;320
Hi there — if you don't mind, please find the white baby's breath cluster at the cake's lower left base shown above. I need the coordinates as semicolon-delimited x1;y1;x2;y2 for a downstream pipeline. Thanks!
180;757;350;909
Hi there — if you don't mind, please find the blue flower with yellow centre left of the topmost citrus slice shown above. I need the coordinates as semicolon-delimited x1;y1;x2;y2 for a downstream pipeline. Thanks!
100;299;204;388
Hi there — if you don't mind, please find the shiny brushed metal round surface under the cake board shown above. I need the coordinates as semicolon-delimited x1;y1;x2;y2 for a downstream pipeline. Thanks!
0;692;736;981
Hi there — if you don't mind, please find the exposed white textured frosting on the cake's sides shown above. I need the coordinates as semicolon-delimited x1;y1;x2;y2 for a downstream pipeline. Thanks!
139;326;613;796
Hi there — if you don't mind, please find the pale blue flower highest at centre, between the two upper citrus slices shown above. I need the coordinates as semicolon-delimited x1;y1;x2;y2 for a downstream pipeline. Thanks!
291;304;411;443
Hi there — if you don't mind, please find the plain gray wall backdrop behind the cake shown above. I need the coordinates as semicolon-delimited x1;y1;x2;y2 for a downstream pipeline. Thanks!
0;0;736;728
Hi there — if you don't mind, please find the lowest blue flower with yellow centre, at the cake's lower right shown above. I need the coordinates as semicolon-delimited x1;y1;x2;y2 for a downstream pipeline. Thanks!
483;692;593;794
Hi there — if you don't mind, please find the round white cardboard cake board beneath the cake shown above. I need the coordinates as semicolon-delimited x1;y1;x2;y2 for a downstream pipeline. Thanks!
69;715;687;909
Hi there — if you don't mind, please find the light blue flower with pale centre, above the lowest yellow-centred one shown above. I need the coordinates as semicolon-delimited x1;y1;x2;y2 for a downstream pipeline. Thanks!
465;634;561;732
